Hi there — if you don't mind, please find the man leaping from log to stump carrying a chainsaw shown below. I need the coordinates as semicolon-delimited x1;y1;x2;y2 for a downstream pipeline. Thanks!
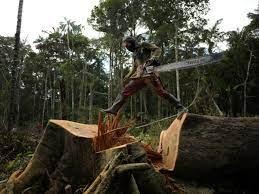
104;37;185;115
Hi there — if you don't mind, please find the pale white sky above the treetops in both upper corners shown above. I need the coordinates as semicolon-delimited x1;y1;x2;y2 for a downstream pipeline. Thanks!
0;0;259;43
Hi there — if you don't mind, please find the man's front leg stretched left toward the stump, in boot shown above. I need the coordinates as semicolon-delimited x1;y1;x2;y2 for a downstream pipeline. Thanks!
104;79;146;115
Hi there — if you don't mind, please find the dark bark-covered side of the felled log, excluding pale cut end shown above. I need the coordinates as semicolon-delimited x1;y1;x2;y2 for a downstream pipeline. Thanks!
174;114;259;185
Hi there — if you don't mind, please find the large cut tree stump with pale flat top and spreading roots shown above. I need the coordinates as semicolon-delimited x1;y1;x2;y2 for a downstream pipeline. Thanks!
0;120;169;194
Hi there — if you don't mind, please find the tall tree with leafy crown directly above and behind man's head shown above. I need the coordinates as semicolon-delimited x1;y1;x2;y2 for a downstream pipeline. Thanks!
88;0;142;105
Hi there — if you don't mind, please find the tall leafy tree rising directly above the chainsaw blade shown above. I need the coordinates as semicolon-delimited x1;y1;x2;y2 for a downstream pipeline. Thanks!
143;0;208;115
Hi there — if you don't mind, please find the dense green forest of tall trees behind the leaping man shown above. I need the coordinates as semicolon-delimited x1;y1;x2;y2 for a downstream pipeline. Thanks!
0;0;259;193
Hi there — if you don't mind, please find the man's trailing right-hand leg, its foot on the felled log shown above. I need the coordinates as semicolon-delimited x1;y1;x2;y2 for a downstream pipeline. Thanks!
150;76;184;111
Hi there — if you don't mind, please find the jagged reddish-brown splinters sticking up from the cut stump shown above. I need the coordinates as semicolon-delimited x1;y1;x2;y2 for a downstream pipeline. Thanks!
94;112;134;152
